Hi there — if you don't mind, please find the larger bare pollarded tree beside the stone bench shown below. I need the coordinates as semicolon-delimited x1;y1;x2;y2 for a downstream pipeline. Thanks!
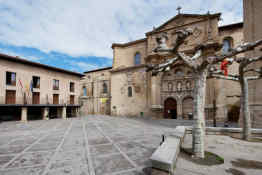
147;29;262;158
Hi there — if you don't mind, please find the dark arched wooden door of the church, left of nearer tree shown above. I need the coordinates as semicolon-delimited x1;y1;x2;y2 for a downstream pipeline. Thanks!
164;98;177;119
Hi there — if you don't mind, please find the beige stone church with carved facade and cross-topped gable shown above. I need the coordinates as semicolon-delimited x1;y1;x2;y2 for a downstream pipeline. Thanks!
81;13;243;121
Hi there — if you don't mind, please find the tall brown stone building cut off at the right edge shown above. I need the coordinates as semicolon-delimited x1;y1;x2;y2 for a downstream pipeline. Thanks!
244;0;262;127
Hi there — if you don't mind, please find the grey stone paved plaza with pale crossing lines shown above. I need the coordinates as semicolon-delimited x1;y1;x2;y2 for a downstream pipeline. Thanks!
0;116;262;175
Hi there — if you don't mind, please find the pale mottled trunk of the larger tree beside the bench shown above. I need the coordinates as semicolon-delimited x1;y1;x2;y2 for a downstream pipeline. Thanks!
192;69;207;158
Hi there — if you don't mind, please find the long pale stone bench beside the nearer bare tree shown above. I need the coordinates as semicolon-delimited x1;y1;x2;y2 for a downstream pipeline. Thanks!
150;126;186;173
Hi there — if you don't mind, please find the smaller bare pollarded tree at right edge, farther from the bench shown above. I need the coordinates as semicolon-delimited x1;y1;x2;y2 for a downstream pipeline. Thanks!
210;56;262;140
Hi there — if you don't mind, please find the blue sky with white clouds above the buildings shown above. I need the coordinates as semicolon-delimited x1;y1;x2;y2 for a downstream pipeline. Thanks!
0;0;243;72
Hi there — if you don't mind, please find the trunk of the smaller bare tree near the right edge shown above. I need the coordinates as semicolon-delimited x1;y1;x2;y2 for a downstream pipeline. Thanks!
240;76;251;140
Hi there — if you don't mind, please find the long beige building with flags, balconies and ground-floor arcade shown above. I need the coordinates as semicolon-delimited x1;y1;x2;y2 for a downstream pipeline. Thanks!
0;54;84;121
